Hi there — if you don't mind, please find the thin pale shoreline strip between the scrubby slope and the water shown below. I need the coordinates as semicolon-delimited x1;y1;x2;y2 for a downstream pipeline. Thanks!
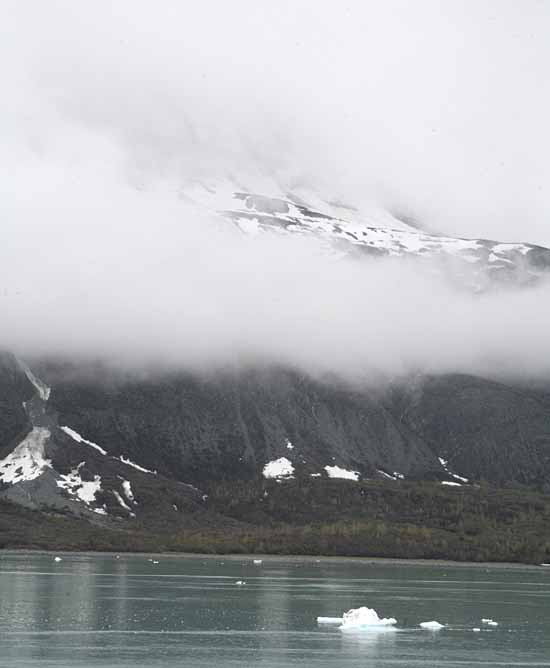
0;548;550;573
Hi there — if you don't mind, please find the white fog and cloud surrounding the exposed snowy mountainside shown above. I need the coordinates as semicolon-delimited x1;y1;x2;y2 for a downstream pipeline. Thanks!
0;1;550;376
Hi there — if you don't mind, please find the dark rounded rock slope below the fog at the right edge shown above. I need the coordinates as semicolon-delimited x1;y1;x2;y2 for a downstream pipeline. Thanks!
394;375;550;485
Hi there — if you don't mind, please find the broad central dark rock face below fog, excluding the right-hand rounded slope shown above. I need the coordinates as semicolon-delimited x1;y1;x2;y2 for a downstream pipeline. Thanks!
45;369;441;483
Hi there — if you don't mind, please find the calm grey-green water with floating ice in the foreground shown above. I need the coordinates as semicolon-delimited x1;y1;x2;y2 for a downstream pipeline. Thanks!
0;553;550;668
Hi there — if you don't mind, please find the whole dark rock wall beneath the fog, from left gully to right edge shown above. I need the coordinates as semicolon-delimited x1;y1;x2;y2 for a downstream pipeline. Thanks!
31;362;550;484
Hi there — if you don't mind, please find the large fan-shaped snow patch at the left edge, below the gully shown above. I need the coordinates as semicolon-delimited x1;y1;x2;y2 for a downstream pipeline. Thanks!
0;427;51;485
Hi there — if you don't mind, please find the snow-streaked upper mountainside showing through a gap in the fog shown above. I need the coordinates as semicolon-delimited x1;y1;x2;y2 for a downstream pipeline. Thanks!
184;183;550;290
